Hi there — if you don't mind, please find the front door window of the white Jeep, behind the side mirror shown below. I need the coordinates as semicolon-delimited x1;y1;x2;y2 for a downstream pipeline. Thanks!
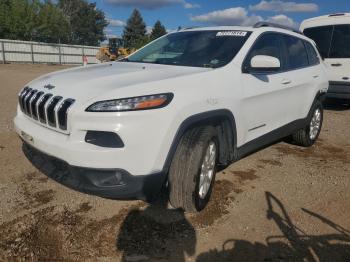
244;33;283;69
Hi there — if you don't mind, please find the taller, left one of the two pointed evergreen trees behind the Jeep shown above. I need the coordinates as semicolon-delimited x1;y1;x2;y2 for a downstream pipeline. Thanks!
123;9;148;49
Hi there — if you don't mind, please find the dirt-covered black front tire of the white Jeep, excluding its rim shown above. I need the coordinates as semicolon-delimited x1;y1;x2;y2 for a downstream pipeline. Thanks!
169;126;219;212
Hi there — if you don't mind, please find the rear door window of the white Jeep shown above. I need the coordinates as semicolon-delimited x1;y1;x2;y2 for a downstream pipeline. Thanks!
283;35;309;70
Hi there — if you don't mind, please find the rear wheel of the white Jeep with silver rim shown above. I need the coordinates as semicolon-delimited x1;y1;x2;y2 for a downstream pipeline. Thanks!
292;100;323;147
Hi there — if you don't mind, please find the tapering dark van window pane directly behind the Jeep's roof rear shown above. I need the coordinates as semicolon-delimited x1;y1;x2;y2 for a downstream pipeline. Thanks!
304;26;333;58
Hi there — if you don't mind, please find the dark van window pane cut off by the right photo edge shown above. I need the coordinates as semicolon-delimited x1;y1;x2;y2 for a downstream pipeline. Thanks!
329;25;350;58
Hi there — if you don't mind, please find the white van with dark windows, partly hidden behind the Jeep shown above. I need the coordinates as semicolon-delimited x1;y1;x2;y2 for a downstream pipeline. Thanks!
300;13;350;101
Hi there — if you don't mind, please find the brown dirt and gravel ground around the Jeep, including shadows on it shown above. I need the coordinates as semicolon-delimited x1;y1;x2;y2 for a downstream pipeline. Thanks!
0;65;350;262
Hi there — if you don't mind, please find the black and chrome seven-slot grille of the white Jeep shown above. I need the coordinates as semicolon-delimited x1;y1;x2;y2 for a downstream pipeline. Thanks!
18;87;75;131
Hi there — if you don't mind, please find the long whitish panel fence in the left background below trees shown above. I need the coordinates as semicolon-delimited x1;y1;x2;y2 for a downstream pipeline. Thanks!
0;39;99;64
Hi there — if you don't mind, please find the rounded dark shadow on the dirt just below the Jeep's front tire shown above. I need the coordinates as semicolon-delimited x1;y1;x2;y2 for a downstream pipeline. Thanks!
116;195;196;262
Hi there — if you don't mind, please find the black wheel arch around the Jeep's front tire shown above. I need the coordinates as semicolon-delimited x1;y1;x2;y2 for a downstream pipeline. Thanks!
163;109;237;174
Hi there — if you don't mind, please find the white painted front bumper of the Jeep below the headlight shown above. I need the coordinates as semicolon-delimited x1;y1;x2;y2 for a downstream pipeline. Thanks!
14;106;176;176
